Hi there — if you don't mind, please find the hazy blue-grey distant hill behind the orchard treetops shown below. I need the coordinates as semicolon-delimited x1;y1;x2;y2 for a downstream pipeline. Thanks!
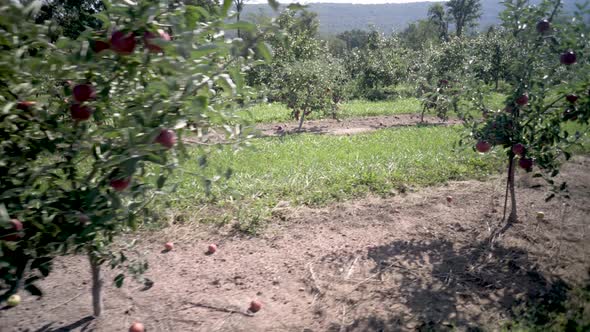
244;0;575;34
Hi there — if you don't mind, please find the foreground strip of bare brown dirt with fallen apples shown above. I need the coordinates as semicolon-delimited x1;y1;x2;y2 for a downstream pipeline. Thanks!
0;157;590;332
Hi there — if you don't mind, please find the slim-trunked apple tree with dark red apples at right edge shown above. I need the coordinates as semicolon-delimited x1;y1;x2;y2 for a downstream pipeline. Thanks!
465;0;590;233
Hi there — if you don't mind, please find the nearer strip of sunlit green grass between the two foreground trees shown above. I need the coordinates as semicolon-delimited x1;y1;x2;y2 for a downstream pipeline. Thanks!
162;127;501;231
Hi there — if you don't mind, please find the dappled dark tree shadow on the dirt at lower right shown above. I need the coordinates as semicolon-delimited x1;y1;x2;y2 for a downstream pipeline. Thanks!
330;240;569;331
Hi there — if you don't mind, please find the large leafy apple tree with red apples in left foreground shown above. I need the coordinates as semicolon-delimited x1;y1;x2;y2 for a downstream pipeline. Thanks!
0;0;264;316
